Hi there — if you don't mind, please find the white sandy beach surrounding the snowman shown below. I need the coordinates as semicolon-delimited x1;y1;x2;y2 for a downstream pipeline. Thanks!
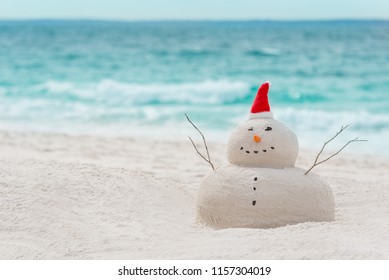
0;131;389;259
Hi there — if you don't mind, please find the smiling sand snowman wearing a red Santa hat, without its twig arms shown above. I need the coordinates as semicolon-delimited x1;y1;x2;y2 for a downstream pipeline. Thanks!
196;82;335;228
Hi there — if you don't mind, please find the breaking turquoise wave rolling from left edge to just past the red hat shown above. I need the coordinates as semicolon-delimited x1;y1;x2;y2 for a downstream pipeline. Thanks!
0;79;334;106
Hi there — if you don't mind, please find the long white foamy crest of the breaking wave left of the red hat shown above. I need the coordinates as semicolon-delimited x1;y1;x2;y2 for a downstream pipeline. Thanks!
37;79;249;104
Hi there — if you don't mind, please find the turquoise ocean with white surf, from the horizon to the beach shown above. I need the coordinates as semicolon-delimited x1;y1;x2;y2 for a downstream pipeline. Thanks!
0;21;389;155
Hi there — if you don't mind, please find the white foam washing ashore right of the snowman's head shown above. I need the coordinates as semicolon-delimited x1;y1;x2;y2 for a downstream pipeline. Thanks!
275;108;389;155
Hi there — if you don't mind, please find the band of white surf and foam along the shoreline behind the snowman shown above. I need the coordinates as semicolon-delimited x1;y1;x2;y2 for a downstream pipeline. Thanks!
0;79;389;155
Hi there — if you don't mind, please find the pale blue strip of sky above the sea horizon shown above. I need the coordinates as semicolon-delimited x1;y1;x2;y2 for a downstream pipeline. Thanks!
0;0;389;20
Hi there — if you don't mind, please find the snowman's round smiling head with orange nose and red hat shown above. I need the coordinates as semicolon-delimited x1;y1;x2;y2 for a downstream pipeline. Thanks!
227;82;298;168
